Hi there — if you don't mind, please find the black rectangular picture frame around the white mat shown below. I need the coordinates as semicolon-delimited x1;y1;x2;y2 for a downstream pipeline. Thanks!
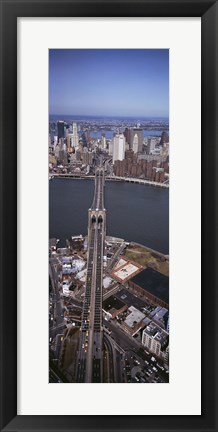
0;0;218;432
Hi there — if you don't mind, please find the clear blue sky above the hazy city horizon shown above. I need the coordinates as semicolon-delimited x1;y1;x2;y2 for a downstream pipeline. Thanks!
49;49;169;117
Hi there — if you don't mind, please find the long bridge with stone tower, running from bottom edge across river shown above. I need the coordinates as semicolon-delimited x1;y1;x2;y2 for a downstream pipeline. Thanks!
77;168;106;383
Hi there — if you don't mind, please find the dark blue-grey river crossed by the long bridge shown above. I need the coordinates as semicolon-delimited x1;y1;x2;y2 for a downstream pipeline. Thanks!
49;179;169;254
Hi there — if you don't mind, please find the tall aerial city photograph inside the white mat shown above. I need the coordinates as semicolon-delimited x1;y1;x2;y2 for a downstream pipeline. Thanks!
48;49;170;384
